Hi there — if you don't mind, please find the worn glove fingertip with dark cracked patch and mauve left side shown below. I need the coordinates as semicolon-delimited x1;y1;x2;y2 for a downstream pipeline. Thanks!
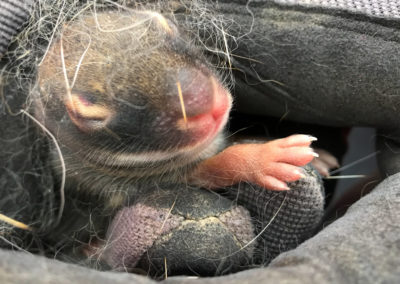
104;185;255;276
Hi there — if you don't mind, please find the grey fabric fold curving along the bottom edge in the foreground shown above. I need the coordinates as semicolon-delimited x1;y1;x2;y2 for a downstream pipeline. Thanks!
0;174;400;284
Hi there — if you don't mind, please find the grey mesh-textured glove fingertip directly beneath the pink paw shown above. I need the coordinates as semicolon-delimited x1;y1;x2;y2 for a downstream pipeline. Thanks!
226;167;324;264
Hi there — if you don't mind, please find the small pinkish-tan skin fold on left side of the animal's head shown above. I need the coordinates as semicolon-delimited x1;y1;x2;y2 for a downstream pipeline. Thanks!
64;94;114;132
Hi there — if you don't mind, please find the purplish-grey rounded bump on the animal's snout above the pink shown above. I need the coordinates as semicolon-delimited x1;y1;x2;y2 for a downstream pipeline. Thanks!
172;68;214;117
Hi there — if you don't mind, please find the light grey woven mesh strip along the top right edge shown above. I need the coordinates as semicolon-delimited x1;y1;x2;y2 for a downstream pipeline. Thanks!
274;0;400;19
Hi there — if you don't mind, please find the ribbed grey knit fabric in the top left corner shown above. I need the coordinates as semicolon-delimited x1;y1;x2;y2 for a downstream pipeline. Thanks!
0;0;33;58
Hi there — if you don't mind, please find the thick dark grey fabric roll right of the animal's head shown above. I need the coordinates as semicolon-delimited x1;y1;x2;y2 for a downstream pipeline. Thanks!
216;1;400;174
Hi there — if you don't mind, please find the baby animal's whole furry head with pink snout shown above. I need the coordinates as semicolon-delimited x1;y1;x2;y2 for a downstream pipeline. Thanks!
36;11;231;173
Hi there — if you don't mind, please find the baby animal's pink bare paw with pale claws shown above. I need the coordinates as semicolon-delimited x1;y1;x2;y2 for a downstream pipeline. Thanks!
191;135;318;190
